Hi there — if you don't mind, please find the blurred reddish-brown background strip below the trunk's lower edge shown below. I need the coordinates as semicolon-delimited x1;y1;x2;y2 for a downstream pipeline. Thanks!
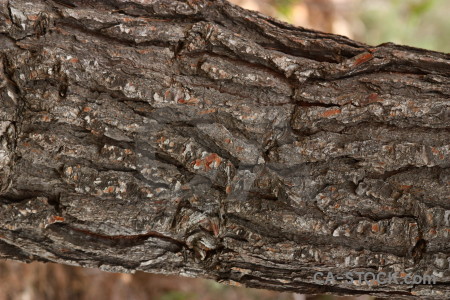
0;261;375;300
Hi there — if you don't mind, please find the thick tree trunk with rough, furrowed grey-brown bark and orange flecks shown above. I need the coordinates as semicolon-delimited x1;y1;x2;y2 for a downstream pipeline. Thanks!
0;0;450;299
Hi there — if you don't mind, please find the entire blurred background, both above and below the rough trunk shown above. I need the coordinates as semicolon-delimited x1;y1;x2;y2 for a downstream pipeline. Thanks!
0;0;450;300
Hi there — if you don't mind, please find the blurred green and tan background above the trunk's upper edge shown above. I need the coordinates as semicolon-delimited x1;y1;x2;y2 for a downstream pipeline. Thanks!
231;0;450;53
